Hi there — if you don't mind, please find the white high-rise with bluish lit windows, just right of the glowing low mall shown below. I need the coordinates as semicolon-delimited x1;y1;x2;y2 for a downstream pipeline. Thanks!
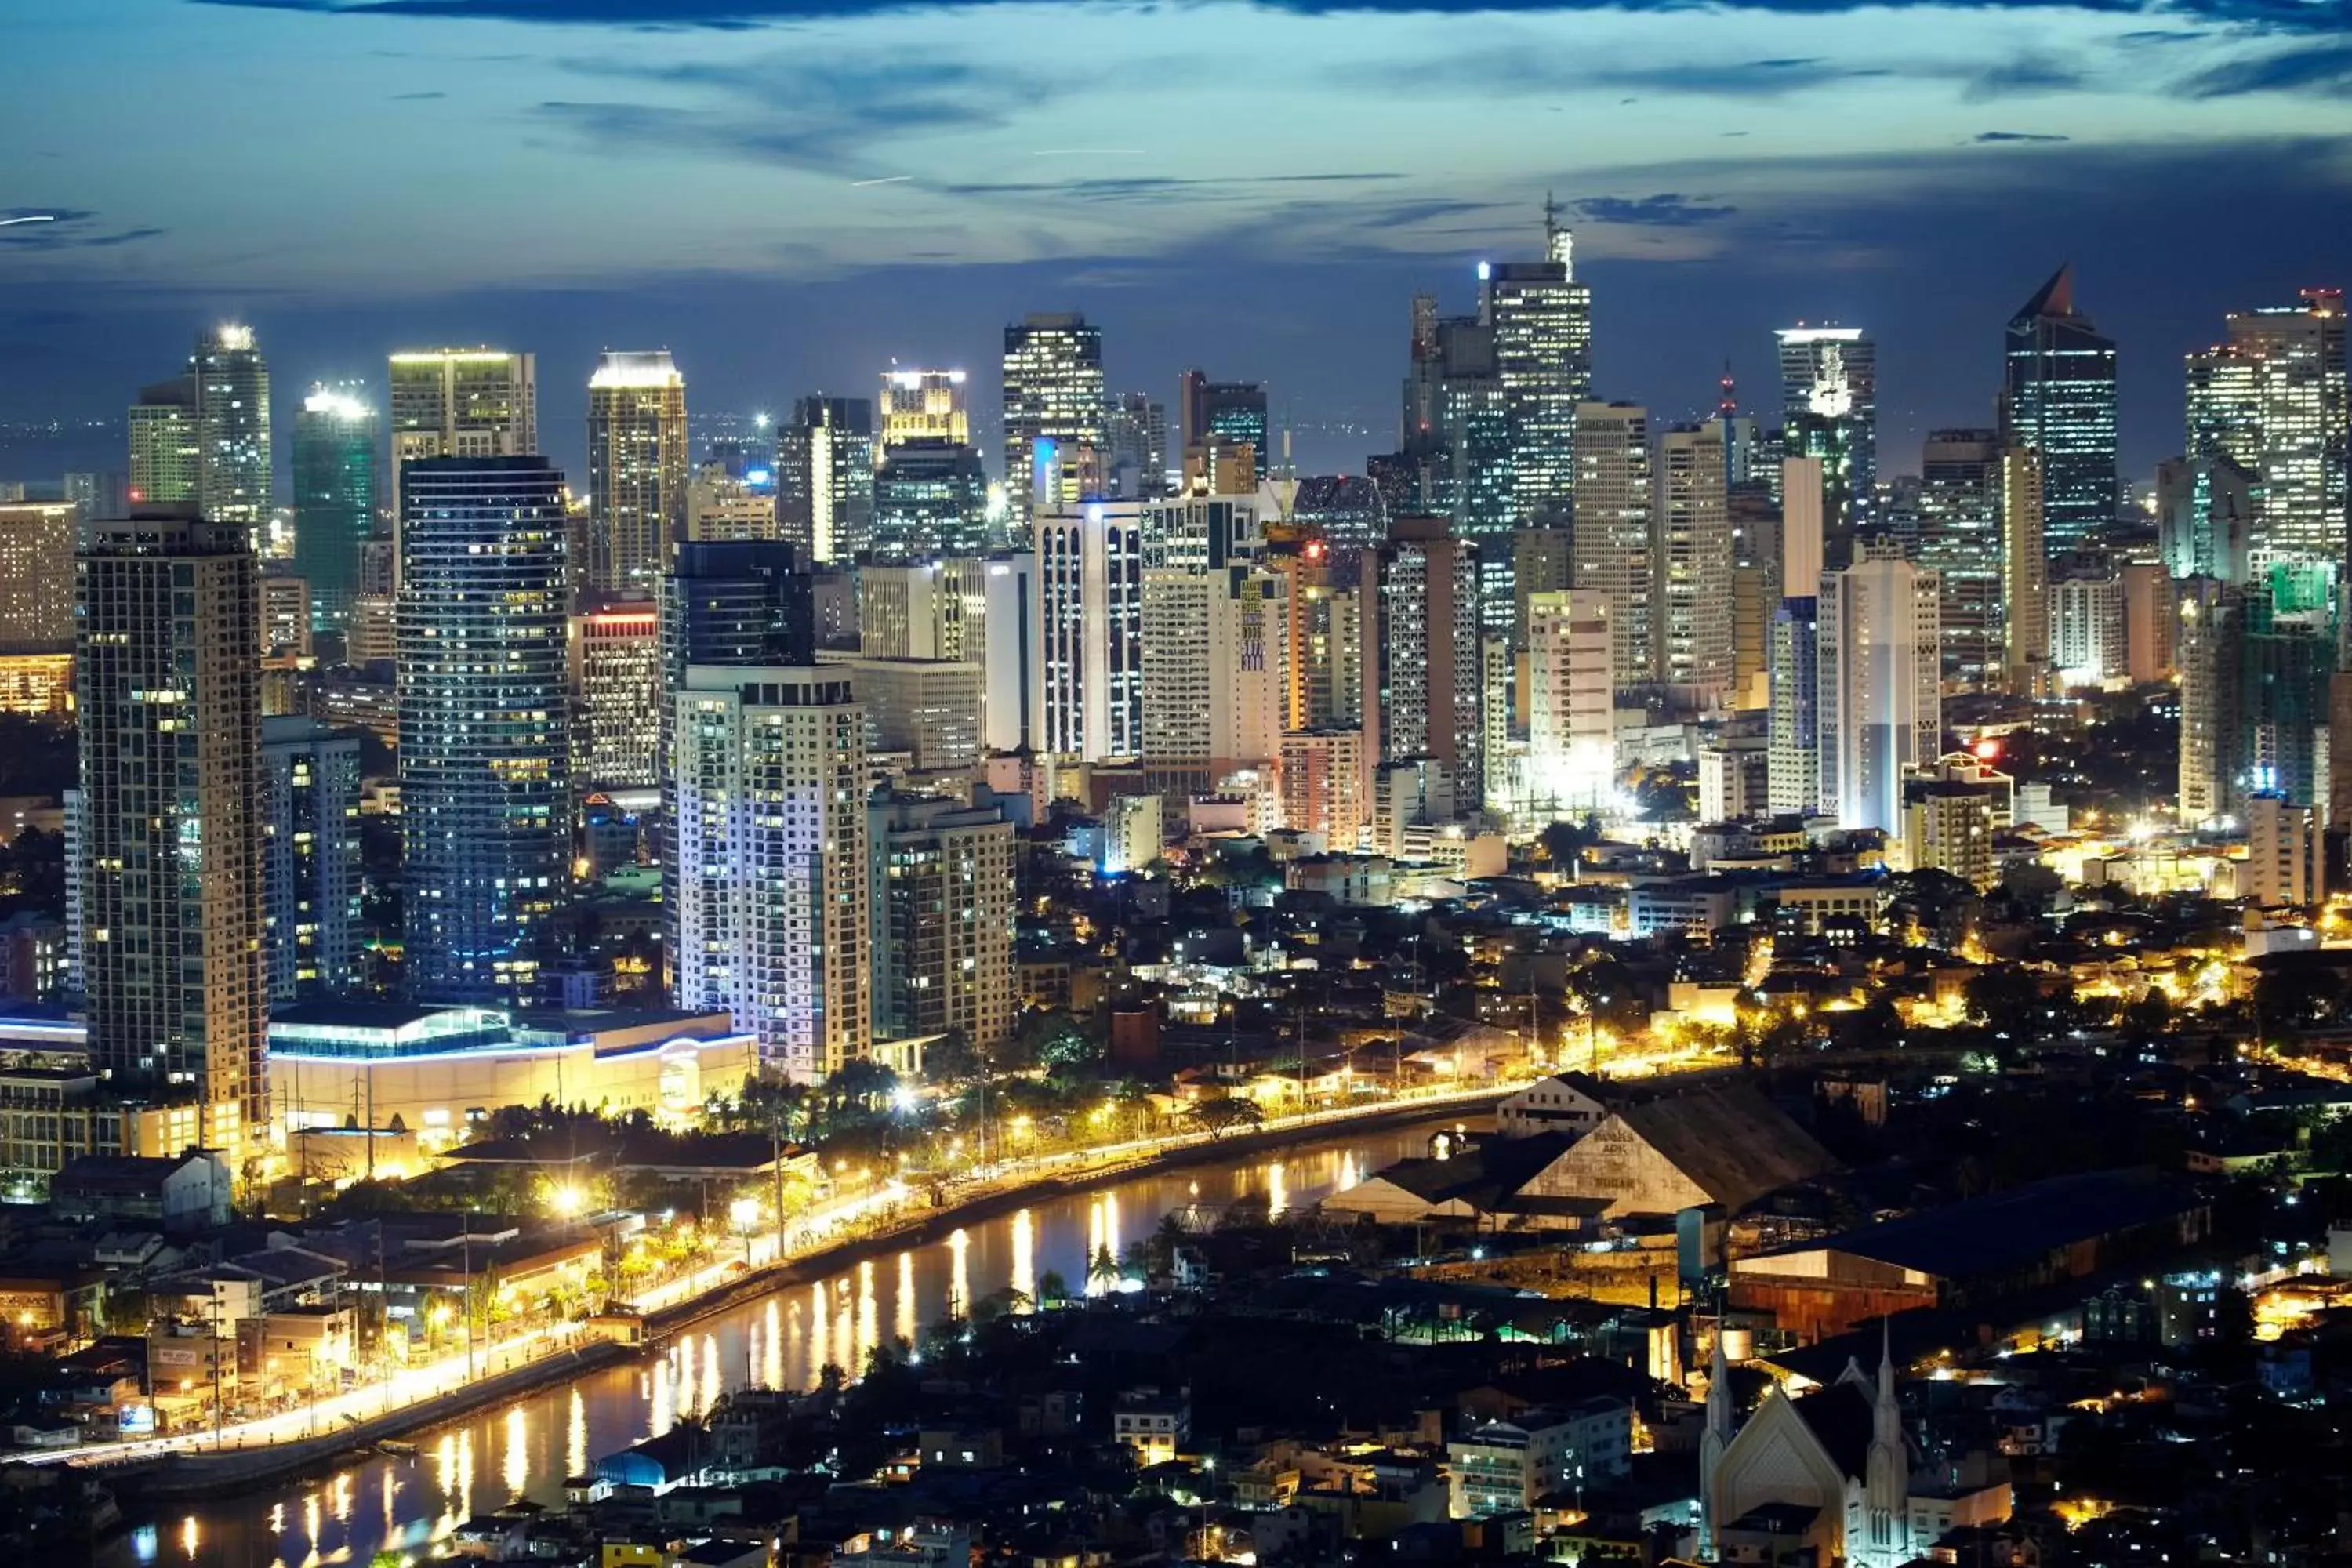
666;663;873;1083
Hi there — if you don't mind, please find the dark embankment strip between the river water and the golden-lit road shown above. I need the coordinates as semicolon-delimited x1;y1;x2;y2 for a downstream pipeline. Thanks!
75;1091;1508;1500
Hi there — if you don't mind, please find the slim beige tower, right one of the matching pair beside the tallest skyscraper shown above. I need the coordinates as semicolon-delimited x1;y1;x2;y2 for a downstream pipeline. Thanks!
1656;423;1731;708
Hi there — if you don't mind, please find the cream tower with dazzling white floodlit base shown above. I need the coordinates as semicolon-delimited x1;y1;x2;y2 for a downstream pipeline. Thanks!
1526;588;1616;818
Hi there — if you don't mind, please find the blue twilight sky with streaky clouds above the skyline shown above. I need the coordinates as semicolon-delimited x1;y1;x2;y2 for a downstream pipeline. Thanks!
0;0;2352;480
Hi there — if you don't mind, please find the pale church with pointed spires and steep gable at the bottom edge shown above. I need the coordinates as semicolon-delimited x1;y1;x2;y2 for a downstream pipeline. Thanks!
1698;1335;2009;1568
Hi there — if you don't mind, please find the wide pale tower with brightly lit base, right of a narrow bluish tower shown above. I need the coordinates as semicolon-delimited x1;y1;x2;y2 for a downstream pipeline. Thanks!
1820;541;1943;834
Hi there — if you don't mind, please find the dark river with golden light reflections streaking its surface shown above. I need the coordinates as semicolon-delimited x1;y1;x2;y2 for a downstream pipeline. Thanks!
99;1123;1430;1568
